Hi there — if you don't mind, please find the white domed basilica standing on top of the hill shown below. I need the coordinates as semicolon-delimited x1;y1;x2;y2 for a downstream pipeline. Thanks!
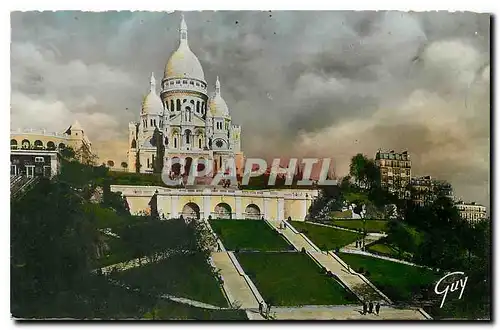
127;17;243;180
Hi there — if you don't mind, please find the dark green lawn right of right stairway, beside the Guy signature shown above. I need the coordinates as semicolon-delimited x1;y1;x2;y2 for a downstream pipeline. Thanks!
339;253;441;302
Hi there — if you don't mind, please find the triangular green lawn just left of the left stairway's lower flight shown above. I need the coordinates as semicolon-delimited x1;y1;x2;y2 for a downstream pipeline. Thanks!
113;254;228;307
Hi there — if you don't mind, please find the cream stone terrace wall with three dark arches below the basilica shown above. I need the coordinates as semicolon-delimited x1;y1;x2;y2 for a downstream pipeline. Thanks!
111;185;317;221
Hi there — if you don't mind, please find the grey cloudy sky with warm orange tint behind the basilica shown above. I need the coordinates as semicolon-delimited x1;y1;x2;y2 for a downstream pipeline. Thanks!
11;11;490;205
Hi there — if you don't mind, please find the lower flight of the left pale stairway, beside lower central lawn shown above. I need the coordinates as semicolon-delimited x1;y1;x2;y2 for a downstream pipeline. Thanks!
211;252;259;309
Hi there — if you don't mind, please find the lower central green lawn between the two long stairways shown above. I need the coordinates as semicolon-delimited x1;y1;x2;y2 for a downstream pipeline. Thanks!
237;252;357;306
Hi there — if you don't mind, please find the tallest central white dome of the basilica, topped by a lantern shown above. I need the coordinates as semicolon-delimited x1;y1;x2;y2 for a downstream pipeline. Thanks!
164;17;205;81
